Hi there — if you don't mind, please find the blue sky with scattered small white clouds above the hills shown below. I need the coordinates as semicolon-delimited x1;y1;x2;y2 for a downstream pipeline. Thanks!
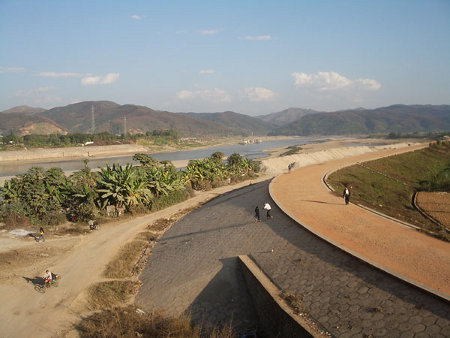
0;0;450;116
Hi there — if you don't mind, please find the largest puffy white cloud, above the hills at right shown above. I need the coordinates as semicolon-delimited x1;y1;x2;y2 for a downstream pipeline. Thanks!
292;72;381;91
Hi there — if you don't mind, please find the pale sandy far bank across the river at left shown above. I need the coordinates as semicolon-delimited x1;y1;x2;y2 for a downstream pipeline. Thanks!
0;144;148;162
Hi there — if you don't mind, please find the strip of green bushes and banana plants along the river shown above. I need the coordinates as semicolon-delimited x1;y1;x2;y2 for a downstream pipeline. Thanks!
0;152;259;230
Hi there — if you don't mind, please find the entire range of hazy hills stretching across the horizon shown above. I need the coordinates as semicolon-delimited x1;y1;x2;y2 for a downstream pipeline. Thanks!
0;101;450;137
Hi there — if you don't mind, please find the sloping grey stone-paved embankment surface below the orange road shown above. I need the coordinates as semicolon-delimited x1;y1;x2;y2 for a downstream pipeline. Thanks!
137;181;450;337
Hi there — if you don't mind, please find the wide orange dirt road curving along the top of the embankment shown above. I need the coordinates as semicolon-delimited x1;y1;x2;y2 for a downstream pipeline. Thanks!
271;145;450;297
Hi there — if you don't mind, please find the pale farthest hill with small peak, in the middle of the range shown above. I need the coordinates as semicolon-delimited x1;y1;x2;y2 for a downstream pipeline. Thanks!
183;111;276;135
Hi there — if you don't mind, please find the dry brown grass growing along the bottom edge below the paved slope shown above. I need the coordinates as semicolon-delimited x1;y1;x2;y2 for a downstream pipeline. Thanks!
77;306;236;338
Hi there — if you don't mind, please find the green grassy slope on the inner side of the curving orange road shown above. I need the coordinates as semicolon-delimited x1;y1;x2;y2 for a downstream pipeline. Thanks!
328;142;450;239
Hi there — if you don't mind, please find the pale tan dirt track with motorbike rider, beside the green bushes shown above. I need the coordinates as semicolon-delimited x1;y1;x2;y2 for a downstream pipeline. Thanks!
0;178;267;337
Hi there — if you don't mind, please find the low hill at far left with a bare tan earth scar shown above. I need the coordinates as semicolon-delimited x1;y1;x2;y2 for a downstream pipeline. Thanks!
0;113;67;136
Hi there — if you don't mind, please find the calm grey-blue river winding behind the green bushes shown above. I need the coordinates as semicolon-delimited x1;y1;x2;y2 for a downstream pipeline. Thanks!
0;137;324;177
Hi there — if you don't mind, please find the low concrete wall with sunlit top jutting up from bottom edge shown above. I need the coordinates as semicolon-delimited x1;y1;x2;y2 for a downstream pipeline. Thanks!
238;255;330;337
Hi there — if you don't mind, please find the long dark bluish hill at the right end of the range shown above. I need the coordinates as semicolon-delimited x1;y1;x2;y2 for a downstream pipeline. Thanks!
271;105;450;136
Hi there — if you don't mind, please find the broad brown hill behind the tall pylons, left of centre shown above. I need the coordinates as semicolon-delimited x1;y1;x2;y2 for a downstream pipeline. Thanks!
36;101;250;136
